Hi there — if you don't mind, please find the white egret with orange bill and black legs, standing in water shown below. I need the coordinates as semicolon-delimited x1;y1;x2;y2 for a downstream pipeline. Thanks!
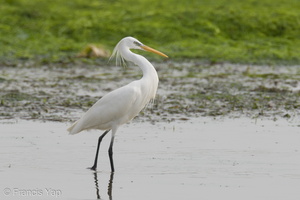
68;37;168;172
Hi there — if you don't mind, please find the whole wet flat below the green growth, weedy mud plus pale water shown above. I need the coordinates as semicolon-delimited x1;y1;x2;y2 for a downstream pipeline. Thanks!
0;63;300;200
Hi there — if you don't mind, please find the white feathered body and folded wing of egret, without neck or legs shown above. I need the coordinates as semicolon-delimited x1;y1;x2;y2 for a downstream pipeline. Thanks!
68;80;150;134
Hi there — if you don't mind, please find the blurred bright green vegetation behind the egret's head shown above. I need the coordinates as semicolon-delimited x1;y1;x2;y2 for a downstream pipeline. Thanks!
0;0;300;64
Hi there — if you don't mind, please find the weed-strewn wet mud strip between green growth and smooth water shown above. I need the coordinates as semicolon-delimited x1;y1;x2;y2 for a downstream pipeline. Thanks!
0;62;300;122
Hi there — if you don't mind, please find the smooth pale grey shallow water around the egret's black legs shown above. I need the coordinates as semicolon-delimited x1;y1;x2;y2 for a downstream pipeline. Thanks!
0;117;300;200
